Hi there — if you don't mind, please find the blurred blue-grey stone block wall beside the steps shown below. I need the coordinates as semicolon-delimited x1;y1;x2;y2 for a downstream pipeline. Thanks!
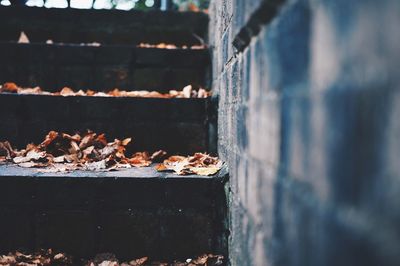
209;0;400;266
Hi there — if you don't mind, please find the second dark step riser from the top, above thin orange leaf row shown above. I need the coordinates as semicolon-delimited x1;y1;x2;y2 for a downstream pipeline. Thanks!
0;43;210;92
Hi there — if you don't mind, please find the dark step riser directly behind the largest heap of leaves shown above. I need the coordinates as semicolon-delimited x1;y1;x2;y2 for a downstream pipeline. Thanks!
0;94;215;154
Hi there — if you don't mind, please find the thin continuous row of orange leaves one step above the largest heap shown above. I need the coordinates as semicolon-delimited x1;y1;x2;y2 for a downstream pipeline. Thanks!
0;82;211;99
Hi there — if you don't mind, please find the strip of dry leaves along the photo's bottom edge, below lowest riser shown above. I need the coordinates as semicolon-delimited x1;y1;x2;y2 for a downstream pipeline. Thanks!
0;249;224;266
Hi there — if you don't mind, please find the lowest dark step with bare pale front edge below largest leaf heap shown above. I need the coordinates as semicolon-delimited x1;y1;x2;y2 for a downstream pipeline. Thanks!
0;165;227;260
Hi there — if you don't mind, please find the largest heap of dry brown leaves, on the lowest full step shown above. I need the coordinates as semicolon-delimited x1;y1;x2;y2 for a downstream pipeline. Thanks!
0;131;222;175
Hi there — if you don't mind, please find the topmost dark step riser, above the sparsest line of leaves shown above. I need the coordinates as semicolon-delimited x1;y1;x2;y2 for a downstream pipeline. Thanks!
0;7;208;45
